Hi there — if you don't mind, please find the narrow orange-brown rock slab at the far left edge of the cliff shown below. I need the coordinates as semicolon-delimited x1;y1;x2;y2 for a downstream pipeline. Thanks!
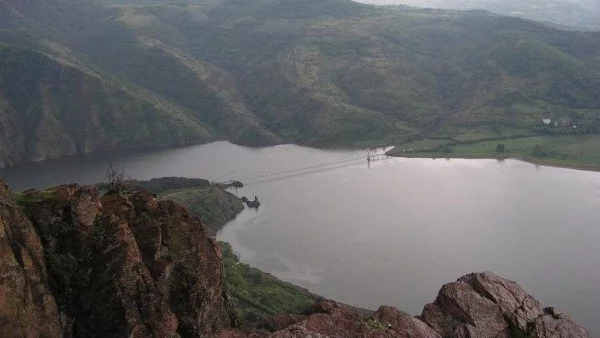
0;181;61;337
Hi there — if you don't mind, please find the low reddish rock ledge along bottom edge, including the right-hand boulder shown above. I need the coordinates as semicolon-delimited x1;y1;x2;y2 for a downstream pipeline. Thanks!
217;272;591;338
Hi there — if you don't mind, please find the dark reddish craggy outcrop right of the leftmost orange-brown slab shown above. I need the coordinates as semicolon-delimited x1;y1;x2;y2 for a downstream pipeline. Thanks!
11;185;230;338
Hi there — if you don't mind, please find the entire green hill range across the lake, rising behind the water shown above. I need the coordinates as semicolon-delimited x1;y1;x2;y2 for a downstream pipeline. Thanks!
0;0;600;165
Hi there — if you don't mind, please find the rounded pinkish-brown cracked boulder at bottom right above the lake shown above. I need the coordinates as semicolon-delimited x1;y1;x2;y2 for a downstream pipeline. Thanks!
421;272;591;338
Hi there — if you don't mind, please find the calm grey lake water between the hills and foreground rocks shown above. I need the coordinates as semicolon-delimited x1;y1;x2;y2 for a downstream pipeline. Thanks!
0;142;600;336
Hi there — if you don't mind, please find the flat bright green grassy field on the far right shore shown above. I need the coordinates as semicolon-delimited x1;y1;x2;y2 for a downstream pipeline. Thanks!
388;135;600;170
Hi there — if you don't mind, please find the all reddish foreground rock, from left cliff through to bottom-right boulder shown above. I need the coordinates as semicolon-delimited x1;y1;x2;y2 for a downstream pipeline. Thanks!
0;181;591;338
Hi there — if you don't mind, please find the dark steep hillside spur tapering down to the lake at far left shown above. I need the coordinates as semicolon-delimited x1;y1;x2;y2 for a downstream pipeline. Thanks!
0;45;214;164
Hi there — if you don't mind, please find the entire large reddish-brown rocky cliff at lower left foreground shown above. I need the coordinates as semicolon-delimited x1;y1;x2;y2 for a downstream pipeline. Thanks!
0;181;230;337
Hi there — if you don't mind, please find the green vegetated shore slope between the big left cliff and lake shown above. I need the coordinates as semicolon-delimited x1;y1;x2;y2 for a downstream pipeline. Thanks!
114;177;319;326
